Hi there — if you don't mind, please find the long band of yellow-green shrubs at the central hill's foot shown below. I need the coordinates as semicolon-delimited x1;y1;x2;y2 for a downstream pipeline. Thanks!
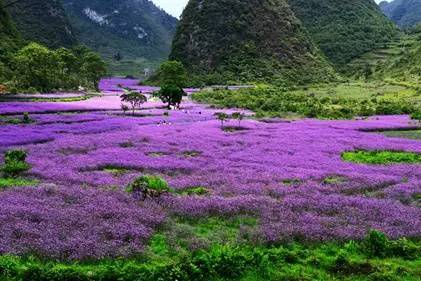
193;86;415;119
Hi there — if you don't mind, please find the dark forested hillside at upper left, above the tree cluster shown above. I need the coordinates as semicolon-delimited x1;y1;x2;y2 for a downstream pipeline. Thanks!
7;0;76;48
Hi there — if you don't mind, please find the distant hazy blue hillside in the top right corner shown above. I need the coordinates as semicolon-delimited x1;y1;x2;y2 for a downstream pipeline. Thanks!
379;0;421;28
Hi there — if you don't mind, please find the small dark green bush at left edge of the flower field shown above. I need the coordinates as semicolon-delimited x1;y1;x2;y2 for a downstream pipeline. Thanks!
1;150;30;178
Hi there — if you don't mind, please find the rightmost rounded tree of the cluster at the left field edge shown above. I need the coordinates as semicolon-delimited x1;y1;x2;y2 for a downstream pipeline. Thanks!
82;52;107;90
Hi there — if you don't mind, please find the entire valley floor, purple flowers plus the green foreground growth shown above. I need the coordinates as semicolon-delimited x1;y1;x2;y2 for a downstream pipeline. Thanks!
0;79;421;280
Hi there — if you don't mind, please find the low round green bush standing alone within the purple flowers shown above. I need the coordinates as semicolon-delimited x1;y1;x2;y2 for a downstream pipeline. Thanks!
126;175;173;200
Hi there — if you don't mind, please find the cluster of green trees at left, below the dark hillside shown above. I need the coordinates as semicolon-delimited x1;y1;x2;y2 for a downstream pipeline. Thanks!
0;43;106;92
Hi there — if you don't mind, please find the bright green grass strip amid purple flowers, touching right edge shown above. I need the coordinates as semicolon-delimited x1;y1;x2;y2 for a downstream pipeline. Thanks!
342;150;421;165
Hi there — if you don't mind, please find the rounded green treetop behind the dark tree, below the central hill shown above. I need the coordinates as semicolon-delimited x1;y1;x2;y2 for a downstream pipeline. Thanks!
157;61;187;88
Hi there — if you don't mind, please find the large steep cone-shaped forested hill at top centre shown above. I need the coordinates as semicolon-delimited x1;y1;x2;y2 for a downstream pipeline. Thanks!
170;0;333;84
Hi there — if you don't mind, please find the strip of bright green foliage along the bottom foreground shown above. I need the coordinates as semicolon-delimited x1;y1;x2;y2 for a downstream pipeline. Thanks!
0;232;420;281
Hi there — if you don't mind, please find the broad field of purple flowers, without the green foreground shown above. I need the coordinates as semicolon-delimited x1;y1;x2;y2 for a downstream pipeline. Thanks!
0;79;421;259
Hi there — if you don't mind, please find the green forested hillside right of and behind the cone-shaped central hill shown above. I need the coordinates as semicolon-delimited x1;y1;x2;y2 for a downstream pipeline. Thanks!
288;0;397;68
